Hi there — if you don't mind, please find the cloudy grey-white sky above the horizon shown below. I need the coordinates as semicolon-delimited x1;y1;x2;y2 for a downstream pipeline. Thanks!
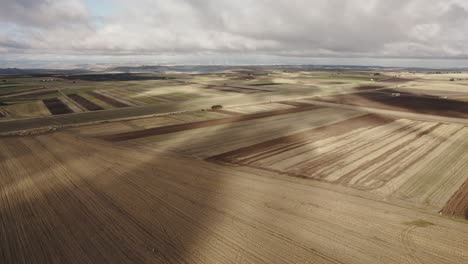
0;0;468;68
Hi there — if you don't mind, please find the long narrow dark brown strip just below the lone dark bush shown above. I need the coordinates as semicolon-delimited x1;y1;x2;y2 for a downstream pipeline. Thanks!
103;105;319;141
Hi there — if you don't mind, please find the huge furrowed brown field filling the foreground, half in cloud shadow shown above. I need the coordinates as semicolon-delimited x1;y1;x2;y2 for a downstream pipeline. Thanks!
0;134;468;264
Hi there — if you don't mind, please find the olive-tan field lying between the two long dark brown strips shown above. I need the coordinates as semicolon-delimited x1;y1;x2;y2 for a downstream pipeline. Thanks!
131;108;362;158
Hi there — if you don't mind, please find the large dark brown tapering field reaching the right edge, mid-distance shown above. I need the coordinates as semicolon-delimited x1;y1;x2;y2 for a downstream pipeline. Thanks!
314;90;468;118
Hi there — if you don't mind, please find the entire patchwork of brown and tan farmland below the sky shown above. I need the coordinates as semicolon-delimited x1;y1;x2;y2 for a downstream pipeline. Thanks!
0;68;468;264
